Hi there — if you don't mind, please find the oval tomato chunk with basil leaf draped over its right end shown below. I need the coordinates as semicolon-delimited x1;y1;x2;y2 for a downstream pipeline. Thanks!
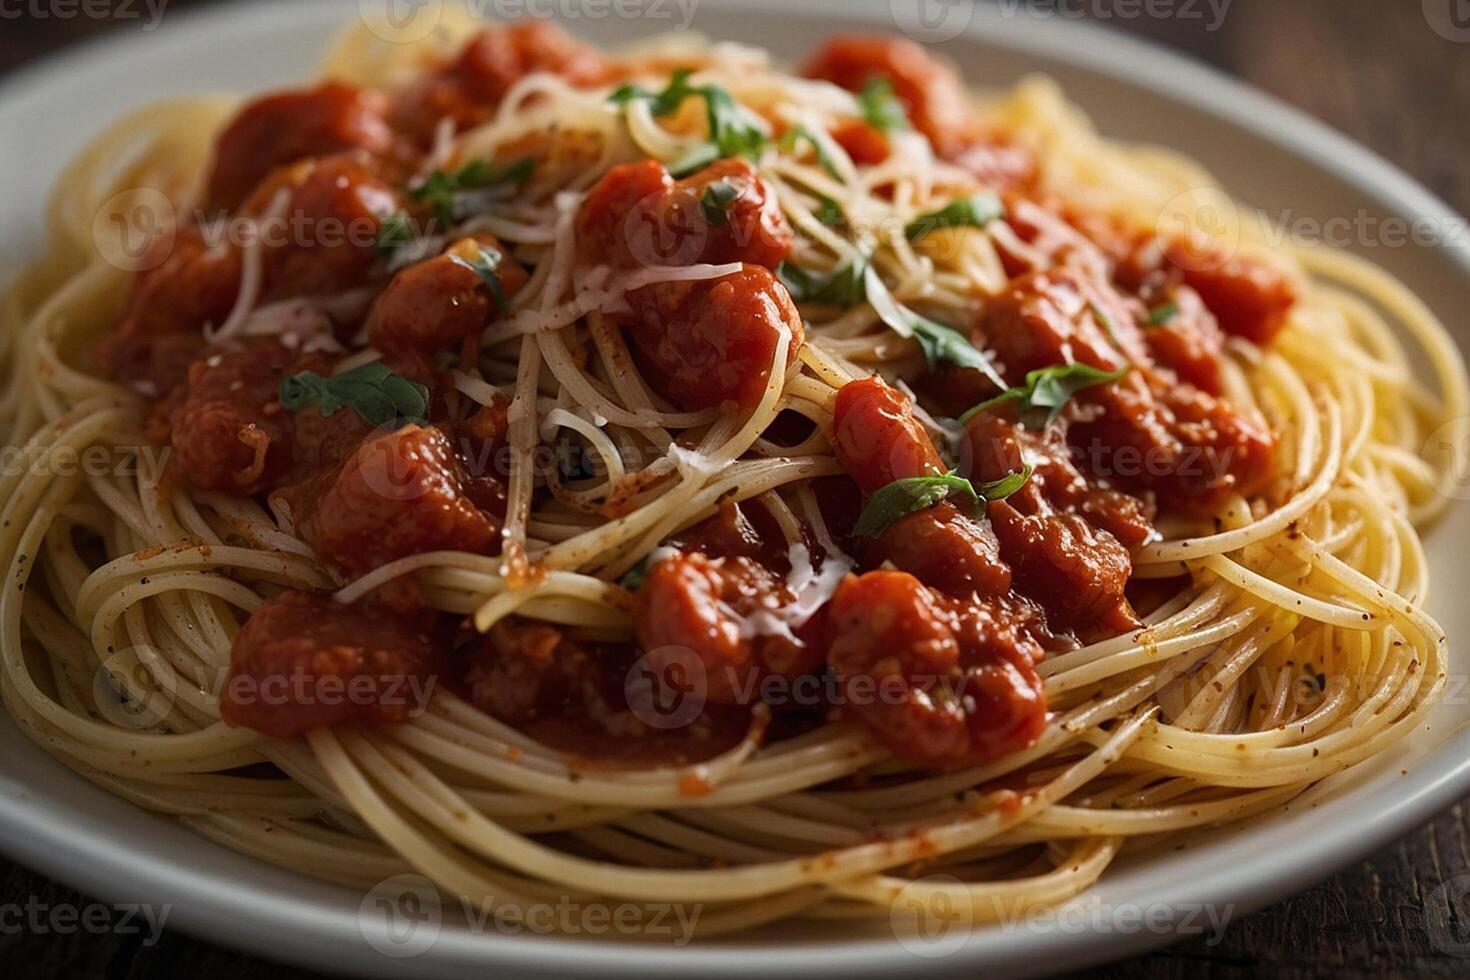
368;235;526;353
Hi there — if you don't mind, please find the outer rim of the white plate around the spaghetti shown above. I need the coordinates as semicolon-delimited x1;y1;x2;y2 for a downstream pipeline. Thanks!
0;0;1470;977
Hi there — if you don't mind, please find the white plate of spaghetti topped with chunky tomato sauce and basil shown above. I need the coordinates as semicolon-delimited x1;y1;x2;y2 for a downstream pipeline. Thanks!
0;3;1470;976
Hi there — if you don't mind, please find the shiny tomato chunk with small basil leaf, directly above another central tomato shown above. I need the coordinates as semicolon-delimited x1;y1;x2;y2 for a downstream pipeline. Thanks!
578;159;795;269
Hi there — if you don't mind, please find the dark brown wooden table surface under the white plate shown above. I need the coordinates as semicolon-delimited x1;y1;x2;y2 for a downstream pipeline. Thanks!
0;0;1470;980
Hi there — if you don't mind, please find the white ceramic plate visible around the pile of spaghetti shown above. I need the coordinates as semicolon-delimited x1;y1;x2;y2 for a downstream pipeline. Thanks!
0;0;1470;979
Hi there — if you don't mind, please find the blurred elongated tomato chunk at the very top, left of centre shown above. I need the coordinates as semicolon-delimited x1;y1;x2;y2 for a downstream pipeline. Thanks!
392;19;607;144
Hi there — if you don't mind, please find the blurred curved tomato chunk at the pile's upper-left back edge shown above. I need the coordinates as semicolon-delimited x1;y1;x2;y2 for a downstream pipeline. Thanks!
206;82;392;210
